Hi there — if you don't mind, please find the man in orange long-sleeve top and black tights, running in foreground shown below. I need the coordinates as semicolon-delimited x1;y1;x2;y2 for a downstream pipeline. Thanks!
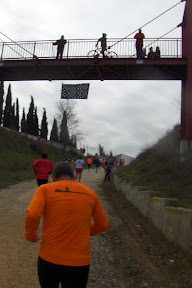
25;162;109;288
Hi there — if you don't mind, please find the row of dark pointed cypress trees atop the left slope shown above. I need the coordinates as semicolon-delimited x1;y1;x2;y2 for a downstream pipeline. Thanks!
0;81;79;148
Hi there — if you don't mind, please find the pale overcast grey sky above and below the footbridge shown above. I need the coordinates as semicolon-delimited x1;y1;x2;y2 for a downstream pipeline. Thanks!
0;0;185;157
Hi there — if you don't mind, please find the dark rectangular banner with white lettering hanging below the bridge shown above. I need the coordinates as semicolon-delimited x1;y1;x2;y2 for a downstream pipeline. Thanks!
61;83;89;99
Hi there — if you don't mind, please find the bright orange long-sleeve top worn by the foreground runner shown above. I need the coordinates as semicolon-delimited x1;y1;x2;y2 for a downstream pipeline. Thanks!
25;180;109;266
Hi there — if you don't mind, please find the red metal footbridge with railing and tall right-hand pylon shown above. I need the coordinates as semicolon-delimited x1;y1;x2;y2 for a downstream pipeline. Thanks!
0;0;192;151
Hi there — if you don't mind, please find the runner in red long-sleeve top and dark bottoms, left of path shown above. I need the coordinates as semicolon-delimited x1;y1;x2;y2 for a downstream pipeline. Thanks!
32;153;54;186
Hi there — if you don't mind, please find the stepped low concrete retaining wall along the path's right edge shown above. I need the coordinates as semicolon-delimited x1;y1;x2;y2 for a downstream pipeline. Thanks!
114;174;192;253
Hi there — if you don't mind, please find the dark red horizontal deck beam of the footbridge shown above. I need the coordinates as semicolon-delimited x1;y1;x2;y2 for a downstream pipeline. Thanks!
0;58;187;81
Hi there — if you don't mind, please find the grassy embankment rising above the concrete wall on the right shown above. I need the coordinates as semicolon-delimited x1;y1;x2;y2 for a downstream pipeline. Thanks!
117;125;192;208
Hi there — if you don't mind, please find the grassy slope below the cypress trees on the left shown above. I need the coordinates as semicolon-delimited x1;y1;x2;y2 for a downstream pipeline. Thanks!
0;127;77;189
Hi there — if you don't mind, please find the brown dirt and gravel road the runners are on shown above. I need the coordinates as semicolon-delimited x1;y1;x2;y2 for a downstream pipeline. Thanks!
0;169;192;288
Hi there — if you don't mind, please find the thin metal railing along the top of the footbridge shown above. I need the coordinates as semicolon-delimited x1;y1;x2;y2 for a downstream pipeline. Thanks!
0;38;182;61
